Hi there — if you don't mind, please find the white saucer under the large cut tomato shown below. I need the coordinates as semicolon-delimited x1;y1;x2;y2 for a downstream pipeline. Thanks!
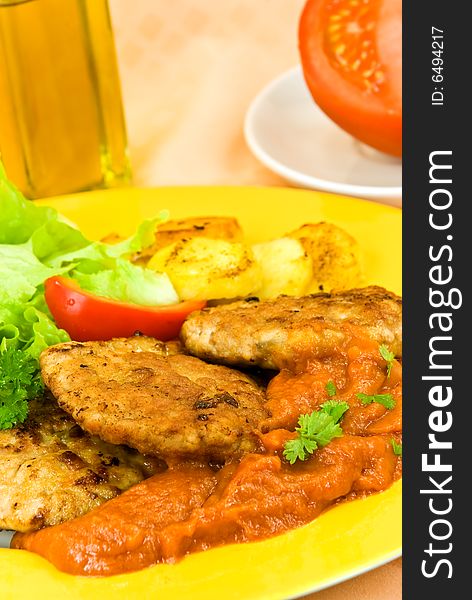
244;66;402;207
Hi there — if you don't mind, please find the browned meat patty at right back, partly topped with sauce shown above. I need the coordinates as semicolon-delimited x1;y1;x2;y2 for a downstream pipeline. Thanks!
181;286;402;369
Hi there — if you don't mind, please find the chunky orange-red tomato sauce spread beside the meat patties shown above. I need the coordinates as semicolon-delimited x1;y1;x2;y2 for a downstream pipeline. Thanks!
12;338;402;575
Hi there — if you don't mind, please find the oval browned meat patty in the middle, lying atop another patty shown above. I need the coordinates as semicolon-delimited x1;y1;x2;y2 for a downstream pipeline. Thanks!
40;337;266;460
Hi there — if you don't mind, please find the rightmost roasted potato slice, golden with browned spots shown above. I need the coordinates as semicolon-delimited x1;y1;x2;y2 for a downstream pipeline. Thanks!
287;223;362;294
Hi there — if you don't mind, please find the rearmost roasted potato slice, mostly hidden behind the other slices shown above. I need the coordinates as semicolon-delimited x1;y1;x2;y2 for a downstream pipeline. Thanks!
132;217;243;265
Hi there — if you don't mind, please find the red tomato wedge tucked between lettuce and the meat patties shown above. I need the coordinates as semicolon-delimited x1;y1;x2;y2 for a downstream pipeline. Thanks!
44;277;206;342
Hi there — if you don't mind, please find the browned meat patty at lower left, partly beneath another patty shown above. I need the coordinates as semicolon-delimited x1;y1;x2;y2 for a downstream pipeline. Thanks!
0;399;165;531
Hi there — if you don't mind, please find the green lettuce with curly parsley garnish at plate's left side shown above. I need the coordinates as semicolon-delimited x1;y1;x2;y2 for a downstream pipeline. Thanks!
0;162;173;429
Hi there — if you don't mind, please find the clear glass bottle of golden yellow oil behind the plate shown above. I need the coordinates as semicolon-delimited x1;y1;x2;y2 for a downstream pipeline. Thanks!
0;0;131;198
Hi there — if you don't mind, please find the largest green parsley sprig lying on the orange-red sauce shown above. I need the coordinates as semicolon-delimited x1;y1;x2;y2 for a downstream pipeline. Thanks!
283;400;349;465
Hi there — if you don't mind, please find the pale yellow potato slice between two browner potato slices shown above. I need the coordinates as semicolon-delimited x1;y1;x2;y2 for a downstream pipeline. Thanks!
252;237;313;300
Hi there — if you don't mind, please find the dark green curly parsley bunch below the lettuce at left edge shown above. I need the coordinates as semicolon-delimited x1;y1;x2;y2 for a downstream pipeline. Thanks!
0;346;44;429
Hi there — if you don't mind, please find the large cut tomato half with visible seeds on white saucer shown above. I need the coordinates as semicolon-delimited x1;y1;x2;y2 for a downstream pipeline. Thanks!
299;0;402;156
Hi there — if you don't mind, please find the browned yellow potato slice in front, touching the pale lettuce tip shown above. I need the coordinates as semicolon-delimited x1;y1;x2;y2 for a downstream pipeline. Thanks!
147;237;261;300
